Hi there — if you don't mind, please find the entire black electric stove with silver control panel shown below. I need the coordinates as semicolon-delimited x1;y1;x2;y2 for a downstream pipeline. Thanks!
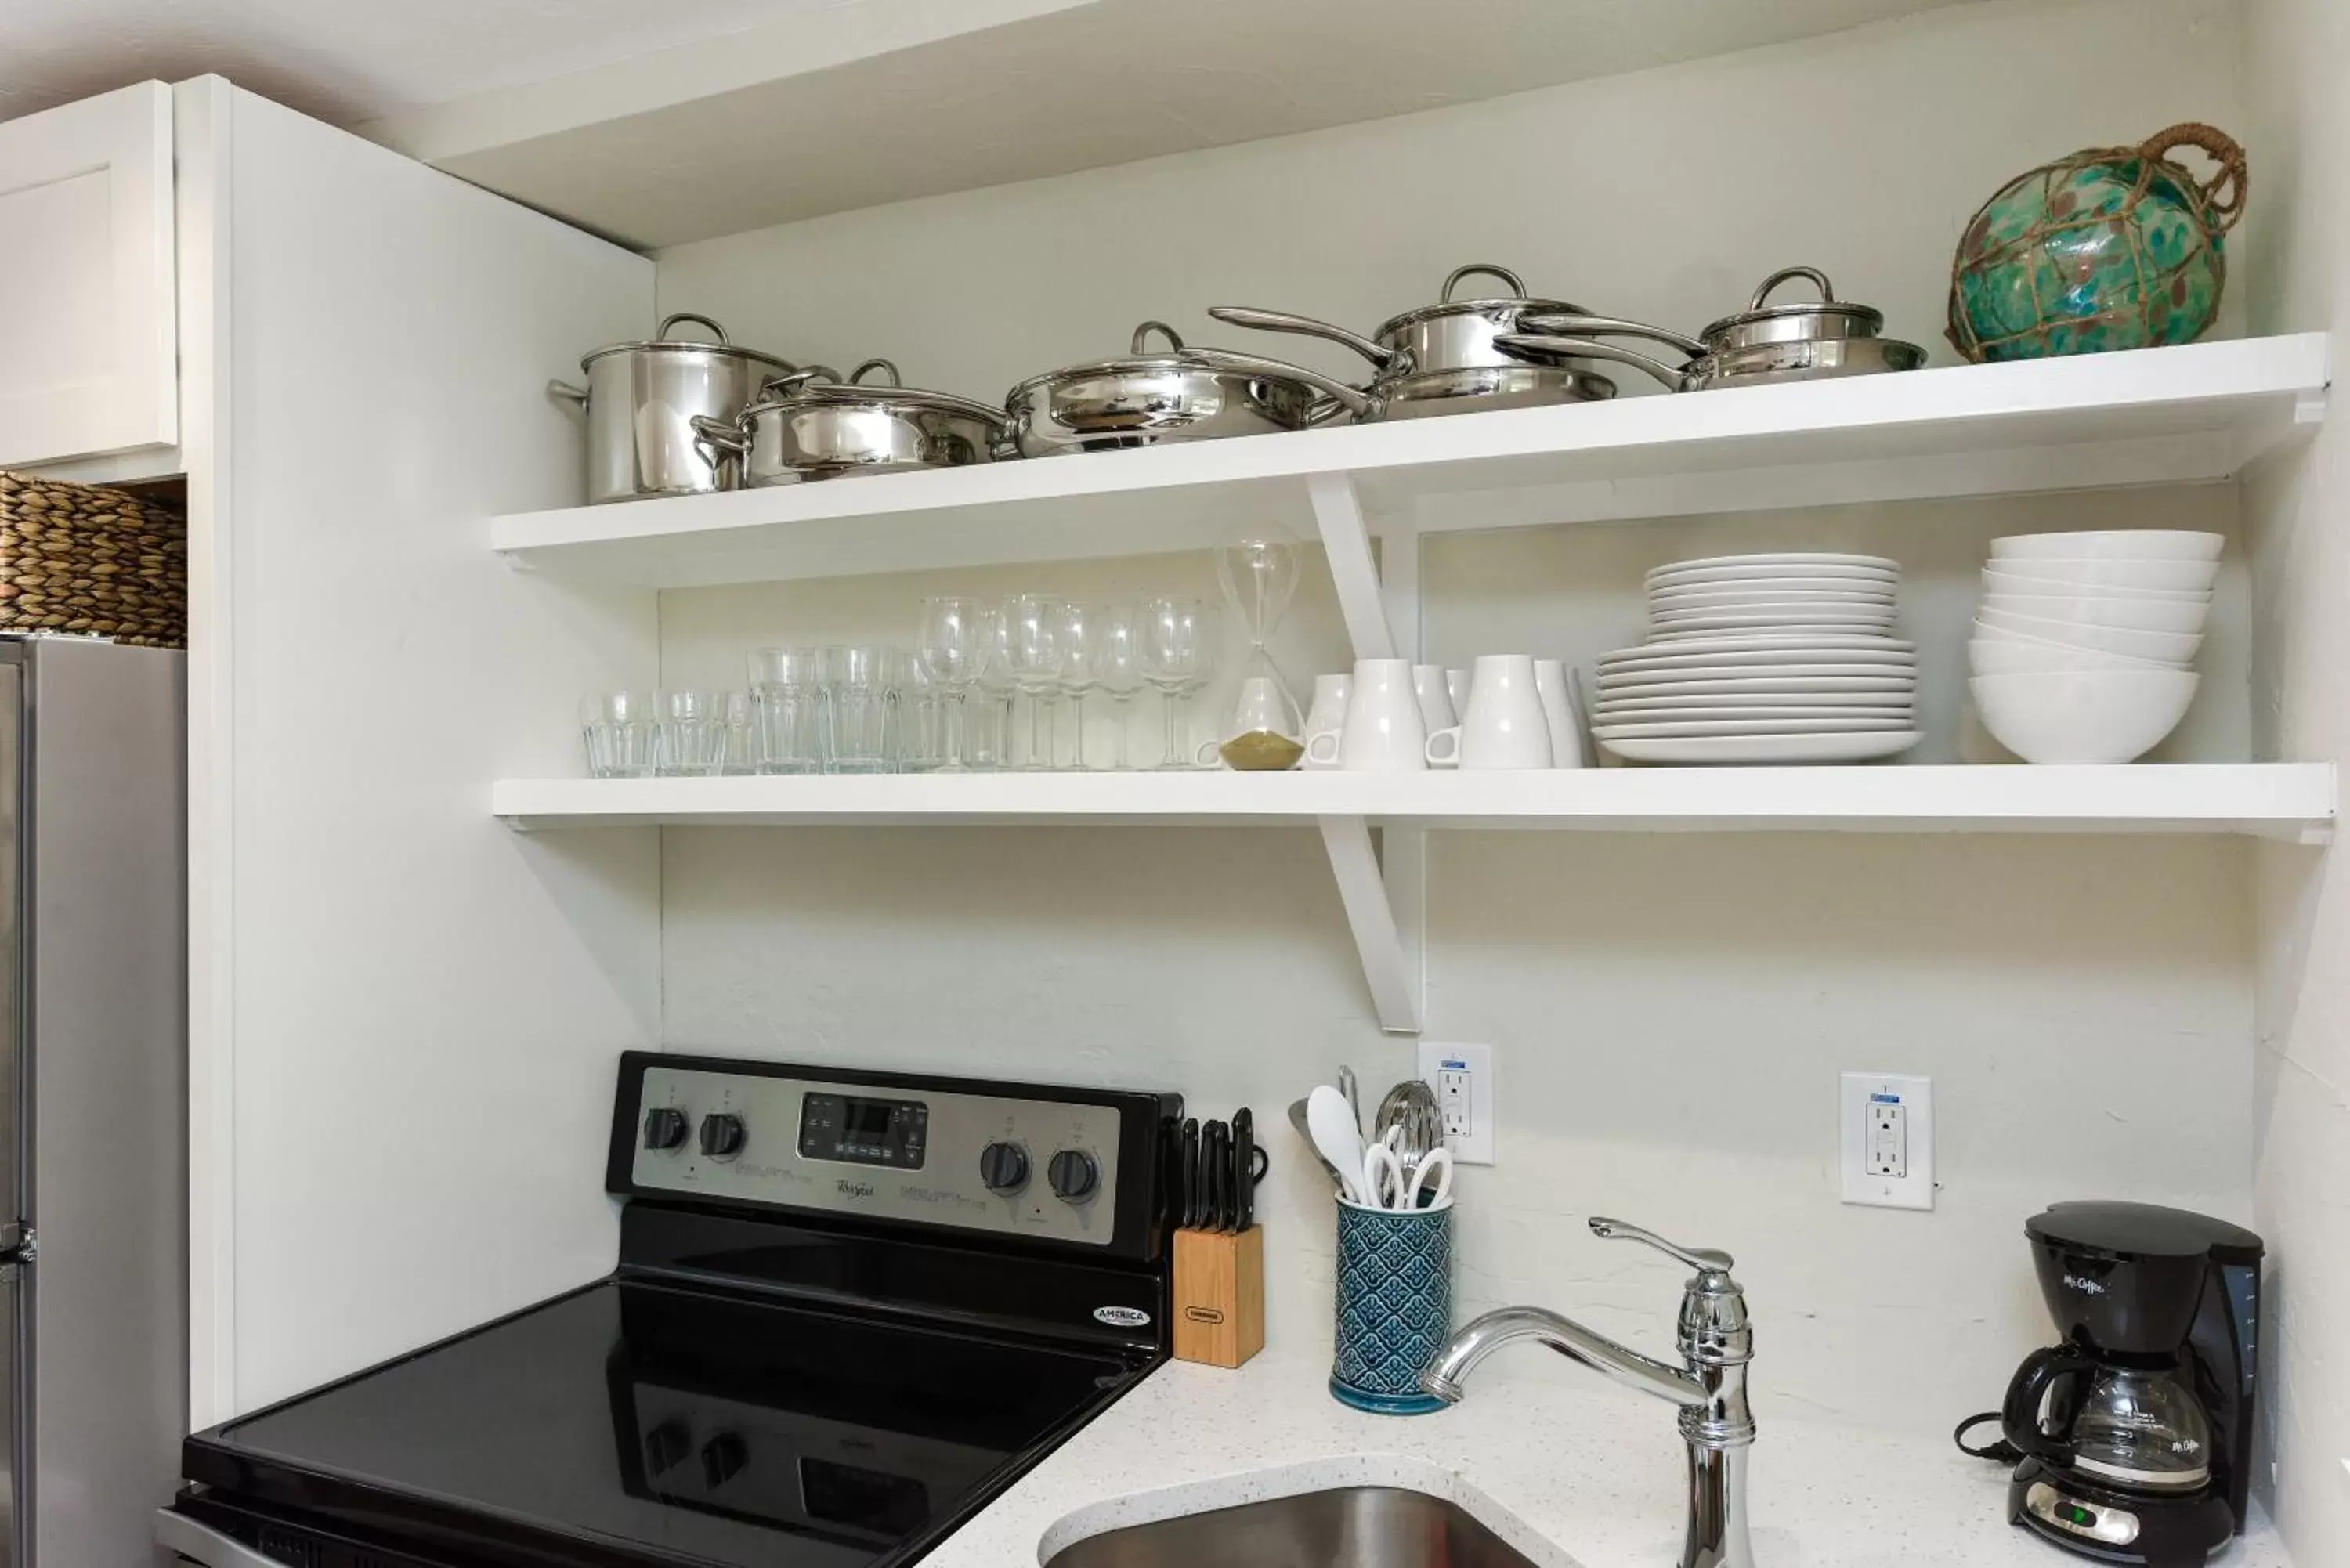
160;1053;1180;1568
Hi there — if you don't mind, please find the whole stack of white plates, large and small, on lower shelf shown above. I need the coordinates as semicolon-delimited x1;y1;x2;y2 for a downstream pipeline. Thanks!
1591;552;1918;761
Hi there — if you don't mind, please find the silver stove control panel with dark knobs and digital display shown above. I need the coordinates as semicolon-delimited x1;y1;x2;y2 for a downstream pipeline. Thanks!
630;1063;1119;1246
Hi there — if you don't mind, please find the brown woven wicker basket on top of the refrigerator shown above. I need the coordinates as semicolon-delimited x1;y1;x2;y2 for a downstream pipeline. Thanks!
0;472;188;649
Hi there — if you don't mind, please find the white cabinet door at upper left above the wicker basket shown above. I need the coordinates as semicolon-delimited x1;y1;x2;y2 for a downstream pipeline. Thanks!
0;82;179;468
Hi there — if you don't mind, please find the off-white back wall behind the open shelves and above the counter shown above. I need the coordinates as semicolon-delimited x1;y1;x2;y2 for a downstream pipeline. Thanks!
660;0;2258;1436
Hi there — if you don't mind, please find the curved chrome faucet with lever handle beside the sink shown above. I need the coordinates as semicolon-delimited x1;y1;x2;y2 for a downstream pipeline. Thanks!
1419;1220;1755;1568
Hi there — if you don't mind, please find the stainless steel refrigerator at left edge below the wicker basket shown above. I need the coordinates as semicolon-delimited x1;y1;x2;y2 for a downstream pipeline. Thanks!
0;637;188;1568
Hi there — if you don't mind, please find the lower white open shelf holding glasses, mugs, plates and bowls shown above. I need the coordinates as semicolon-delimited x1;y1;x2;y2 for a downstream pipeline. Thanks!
491;761;2336;842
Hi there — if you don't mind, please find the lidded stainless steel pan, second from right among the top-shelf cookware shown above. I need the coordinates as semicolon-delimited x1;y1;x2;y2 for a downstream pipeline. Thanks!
1208;261;1617;418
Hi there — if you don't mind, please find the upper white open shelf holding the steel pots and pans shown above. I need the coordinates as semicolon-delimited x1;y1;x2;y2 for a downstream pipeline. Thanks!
491;334;2326;587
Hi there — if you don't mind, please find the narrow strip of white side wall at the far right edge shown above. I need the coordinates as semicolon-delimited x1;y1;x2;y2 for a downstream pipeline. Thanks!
2244;0;2350;1563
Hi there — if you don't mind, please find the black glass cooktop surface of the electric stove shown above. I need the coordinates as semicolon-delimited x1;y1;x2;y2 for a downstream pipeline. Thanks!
186;1279;1149;1568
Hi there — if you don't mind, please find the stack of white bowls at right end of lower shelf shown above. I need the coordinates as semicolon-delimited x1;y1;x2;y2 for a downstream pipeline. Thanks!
1967;529;2223;761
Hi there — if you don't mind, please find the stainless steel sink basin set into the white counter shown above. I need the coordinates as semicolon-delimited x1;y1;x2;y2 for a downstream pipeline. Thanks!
1043;1486;1535;1568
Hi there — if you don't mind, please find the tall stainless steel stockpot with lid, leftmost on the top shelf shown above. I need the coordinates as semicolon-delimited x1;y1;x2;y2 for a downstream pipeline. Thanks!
548;310;794;503
